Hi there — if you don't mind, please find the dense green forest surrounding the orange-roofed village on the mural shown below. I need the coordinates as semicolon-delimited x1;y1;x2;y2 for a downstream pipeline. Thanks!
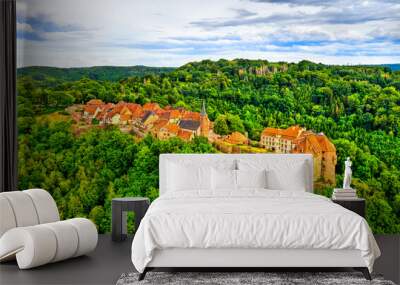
17;59;400;233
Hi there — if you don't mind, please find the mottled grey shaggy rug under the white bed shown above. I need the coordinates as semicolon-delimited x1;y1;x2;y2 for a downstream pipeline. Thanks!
117;272;395;285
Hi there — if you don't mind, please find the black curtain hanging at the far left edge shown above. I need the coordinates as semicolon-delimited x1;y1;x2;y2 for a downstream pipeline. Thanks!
0;0;17;191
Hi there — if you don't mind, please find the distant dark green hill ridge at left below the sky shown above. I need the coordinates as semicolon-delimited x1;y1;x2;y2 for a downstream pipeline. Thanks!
17;65;174;81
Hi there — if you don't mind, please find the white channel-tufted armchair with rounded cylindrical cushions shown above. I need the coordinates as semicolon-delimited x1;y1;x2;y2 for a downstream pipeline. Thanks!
0;189;98;269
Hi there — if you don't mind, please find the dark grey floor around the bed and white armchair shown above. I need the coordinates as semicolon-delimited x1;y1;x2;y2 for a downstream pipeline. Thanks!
0;235;400;285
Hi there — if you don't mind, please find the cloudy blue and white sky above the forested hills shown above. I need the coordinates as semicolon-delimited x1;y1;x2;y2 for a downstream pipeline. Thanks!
17;0;400;67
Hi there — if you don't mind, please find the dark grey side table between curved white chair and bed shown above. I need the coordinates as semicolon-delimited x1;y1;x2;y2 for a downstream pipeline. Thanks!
111;197;150;241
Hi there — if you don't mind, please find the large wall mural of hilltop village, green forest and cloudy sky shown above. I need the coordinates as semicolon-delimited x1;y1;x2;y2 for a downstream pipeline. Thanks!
17;0;400;233
